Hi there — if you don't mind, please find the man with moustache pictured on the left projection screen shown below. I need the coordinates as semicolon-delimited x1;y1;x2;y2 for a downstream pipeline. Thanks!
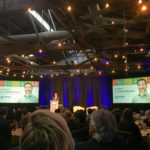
18;83;38;103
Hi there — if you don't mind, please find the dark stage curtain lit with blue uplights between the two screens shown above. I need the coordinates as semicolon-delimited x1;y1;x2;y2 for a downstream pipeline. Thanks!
40;76;112;108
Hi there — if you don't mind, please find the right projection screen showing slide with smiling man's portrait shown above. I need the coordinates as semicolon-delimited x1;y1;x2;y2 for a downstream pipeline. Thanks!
112;77;150;103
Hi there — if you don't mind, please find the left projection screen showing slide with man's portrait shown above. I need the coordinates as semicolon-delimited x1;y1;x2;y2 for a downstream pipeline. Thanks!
0;80;39;103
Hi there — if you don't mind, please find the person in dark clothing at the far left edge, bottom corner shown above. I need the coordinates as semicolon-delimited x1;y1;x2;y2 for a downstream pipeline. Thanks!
0;107;11;150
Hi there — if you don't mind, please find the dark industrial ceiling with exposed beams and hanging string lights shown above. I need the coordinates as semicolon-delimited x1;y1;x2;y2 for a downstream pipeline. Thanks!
0;0;150;78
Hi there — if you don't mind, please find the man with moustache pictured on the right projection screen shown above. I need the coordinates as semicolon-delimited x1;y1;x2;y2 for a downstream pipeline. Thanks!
132;79;150;103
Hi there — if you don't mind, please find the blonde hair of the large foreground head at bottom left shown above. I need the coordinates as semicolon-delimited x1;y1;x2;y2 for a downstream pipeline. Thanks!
20;110;74;150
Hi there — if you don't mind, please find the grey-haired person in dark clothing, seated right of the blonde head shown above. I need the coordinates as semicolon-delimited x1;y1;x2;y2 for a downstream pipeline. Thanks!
76;109;120;150
